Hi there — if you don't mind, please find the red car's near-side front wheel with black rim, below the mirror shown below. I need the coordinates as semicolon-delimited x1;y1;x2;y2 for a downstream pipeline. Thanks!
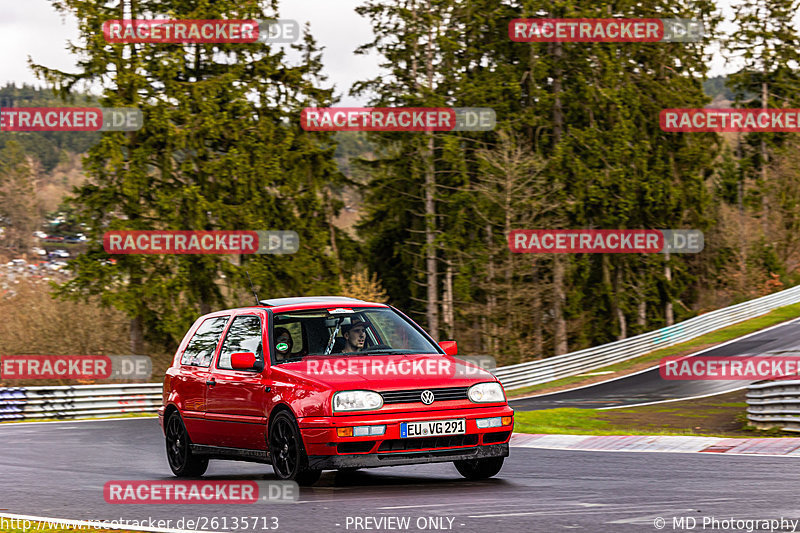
268;411;322;486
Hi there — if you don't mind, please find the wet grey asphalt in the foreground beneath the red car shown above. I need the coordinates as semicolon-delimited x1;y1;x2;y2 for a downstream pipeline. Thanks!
0;419;800;533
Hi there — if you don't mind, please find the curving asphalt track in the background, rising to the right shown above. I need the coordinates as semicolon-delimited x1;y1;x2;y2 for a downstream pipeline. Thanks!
509;320;800;411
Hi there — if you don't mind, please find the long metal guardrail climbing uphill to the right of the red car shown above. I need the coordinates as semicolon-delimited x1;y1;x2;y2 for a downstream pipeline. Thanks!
495;286;800;390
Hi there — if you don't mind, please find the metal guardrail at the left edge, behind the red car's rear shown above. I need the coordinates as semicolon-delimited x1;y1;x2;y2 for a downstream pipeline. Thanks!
0;383;161;421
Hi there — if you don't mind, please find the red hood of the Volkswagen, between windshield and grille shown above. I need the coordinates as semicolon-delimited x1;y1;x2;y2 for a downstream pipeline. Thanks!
274;354;495;391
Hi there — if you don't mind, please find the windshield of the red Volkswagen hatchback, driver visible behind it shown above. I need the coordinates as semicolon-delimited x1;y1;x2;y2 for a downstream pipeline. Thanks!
273;307;440;363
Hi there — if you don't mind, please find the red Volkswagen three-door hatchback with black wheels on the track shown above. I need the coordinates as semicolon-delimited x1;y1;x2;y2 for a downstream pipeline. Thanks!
159;296;514;484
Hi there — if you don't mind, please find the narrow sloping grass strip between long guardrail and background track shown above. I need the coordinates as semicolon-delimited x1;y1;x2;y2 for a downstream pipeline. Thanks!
508;304;800;398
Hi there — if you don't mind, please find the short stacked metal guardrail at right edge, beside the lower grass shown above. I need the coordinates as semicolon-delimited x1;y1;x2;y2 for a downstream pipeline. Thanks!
747;380;800;432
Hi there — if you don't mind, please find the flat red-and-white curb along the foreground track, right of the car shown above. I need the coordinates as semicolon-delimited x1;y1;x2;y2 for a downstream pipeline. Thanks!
511;433;800;456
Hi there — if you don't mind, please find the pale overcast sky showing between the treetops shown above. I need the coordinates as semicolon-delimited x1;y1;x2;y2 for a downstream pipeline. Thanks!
0;0;772;106
